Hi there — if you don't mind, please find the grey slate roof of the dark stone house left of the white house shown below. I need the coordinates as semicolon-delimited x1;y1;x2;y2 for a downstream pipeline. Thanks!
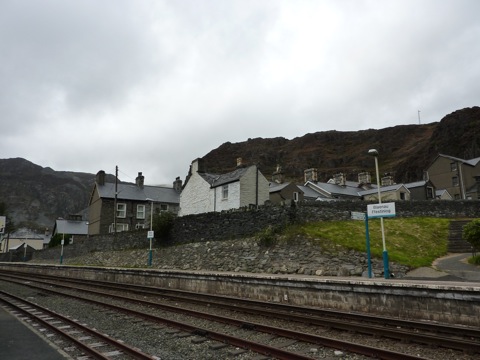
97;183;180;204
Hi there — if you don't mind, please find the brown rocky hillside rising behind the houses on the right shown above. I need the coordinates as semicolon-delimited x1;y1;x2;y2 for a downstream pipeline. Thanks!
204;107;480;183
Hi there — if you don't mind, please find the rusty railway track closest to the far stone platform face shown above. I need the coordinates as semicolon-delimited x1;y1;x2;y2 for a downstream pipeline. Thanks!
1;276;480;353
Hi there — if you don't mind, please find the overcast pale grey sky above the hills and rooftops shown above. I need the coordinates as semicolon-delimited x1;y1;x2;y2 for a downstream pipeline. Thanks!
0;0;480;185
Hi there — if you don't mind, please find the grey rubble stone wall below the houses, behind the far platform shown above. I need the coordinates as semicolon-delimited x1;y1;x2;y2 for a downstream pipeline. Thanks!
33;201;480;276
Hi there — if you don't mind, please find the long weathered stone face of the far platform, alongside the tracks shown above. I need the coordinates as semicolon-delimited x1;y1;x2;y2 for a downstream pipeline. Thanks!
0;263;480;327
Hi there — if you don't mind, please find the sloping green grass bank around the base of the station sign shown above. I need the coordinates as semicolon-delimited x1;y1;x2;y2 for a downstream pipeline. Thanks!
286;218;450;268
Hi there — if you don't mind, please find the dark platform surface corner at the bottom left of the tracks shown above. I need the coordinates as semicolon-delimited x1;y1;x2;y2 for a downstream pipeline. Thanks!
0;307;69;360
